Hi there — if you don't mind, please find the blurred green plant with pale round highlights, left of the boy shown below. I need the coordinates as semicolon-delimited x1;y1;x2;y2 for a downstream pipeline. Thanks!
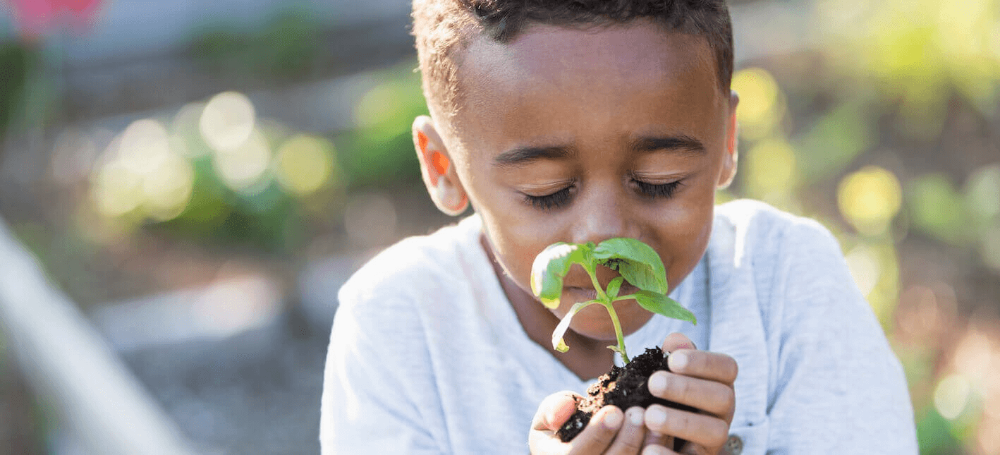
91;92;343;252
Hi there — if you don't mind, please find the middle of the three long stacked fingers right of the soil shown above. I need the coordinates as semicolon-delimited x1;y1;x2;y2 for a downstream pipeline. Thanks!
647;371;736;417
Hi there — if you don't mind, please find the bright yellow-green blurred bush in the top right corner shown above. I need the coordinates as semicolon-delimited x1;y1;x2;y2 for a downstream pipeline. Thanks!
815;0;1000;140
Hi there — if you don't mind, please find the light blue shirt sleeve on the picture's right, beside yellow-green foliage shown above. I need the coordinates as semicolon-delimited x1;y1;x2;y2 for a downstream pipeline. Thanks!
767;221;917;455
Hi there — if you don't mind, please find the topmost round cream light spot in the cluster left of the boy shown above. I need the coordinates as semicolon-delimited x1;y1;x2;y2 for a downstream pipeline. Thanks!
199;92;257;152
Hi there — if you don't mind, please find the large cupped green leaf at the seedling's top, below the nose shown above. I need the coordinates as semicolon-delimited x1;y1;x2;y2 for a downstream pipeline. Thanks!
594;238;668;294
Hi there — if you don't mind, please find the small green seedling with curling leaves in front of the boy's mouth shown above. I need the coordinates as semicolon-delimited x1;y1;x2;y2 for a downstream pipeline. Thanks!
531;238;697;364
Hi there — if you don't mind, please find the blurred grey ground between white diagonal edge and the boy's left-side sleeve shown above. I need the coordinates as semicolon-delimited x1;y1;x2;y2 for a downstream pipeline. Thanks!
124;313;328;454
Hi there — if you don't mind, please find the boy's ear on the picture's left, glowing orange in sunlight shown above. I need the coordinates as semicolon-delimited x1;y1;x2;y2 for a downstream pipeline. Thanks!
413;115;469;216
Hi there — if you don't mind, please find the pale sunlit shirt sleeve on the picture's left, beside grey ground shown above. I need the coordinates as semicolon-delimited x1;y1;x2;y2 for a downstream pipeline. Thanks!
320;287;444;455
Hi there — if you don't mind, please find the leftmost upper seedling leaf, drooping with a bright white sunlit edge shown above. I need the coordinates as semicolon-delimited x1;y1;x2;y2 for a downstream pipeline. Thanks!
531;242;594;308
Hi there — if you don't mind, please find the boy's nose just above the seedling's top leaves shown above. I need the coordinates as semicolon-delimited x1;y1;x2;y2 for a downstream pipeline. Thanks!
572;183;640;244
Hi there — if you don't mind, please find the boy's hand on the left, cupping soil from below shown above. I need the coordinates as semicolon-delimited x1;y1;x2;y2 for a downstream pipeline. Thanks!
528;392;646;455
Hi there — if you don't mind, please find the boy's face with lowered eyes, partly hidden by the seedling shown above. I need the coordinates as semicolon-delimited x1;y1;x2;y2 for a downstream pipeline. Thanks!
430;21;735;339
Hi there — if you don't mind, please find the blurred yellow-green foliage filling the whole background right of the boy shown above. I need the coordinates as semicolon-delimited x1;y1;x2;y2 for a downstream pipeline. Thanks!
733;0;1000;454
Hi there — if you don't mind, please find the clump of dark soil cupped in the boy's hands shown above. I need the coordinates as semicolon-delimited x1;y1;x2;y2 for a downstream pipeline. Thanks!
556;348;695;442
